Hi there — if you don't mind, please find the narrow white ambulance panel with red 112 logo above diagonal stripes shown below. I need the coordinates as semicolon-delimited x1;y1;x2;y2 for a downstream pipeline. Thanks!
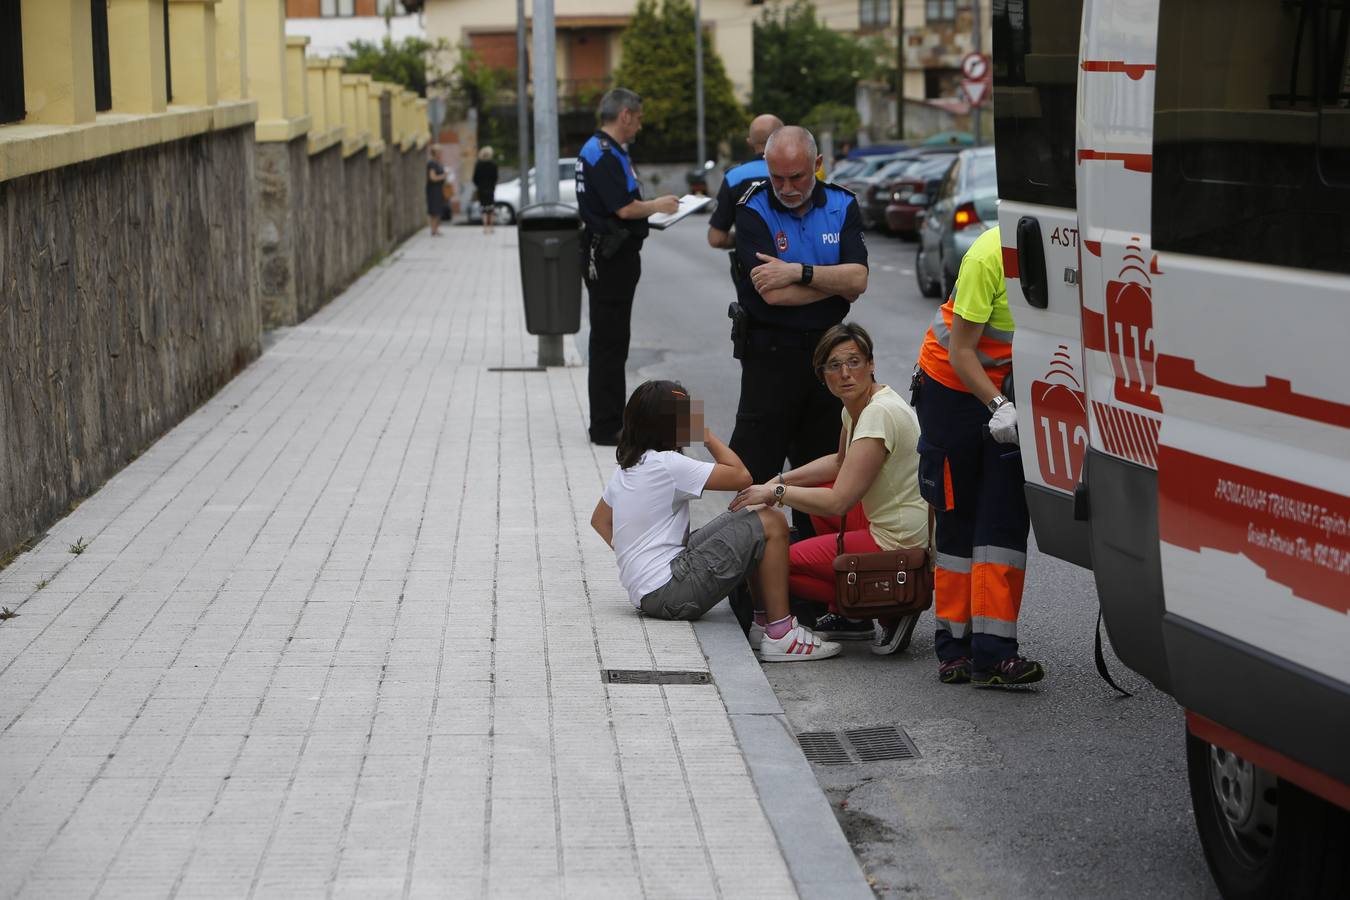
1076;0;1169;690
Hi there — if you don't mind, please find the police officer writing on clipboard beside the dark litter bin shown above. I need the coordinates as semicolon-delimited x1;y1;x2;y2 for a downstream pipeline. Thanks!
576;88;679;447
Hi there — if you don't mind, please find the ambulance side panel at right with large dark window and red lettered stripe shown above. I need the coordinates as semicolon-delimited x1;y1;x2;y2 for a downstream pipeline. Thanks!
1150;0;1350;788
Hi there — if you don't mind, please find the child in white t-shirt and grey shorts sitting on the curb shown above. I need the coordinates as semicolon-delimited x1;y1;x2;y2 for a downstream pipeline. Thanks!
591;381;840;663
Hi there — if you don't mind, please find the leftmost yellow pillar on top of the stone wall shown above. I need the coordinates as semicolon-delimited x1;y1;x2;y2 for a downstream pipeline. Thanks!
19;0;95;125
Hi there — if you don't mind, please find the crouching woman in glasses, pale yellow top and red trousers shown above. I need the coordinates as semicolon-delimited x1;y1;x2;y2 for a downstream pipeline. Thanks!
732;322;927;654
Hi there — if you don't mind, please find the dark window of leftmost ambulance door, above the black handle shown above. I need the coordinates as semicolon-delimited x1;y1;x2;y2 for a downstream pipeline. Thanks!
994;0;1083;209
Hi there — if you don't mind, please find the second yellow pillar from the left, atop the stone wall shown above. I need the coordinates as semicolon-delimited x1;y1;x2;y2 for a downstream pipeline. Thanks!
109;0;169;112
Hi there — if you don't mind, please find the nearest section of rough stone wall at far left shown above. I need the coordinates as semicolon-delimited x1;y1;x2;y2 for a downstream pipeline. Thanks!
0;124;262;551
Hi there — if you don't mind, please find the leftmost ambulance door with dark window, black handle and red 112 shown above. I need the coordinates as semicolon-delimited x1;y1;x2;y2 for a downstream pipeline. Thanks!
992;0;1092;567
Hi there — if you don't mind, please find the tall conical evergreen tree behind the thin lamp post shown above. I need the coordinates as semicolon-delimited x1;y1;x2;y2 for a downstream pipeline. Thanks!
614;0;745;162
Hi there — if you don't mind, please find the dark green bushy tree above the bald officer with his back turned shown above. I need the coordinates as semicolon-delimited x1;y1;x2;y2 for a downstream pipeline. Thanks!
752;0;880;136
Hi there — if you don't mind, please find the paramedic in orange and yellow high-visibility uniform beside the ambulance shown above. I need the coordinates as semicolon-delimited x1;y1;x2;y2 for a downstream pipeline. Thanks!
917;228;1045;687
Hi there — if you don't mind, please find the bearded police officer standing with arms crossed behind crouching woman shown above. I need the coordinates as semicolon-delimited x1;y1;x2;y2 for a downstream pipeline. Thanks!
730;125;868;504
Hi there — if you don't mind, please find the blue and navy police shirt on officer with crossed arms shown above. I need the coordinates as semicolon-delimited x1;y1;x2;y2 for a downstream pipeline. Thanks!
736;181;867;331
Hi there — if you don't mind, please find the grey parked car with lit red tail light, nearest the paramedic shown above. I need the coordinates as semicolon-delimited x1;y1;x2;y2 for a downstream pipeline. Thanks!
910;147;999;297
